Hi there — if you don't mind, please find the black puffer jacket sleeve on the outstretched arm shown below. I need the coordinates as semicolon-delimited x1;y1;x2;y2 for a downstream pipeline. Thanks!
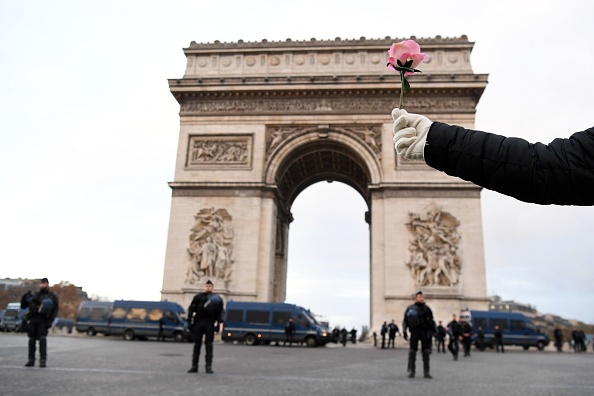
424;122;594;206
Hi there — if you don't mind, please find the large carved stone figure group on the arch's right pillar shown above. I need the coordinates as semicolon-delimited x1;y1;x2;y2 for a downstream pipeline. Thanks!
406;206;462;286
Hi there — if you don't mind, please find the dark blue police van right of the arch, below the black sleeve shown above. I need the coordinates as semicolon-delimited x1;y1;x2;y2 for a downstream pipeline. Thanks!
460;310;550;351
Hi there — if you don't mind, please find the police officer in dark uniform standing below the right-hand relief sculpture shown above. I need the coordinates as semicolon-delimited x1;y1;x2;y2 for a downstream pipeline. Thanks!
402;291;436;378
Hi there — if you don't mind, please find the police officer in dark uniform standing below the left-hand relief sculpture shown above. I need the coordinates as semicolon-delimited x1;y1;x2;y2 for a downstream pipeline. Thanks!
188;280;225;374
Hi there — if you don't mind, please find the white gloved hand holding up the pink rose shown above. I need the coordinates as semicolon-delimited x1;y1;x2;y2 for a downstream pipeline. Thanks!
392;109;433;159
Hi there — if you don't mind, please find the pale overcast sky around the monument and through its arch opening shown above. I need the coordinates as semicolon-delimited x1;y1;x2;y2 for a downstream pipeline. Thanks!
0;0;594;327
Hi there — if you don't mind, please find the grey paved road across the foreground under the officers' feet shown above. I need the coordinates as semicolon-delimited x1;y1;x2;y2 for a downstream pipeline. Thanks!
0;333;594;396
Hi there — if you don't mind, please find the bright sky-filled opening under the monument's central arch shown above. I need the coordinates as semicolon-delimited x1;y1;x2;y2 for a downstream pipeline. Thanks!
286;181;371;330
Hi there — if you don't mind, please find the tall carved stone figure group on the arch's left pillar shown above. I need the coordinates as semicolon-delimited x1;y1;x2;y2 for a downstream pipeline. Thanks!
186;207;234;284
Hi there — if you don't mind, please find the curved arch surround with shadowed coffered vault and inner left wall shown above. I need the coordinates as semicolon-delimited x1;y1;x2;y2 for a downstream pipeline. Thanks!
266;126;381;310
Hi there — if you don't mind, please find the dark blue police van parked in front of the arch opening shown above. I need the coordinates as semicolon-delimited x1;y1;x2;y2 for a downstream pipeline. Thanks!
221;300;331;347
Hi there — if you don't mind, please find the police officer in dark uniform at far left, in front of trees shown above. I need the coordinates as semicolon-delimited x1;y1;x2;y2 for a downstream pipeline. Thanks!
21;278;58;367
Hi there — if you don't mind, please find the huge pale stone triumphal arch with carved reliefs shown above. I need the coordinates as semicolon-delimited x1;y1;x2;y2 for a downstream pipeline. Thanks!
162;36;487;328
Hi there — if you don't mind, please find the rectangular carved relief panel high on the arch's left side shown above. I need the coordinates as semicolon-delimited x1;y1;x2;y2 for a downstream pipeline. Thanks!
188;136;251;166
